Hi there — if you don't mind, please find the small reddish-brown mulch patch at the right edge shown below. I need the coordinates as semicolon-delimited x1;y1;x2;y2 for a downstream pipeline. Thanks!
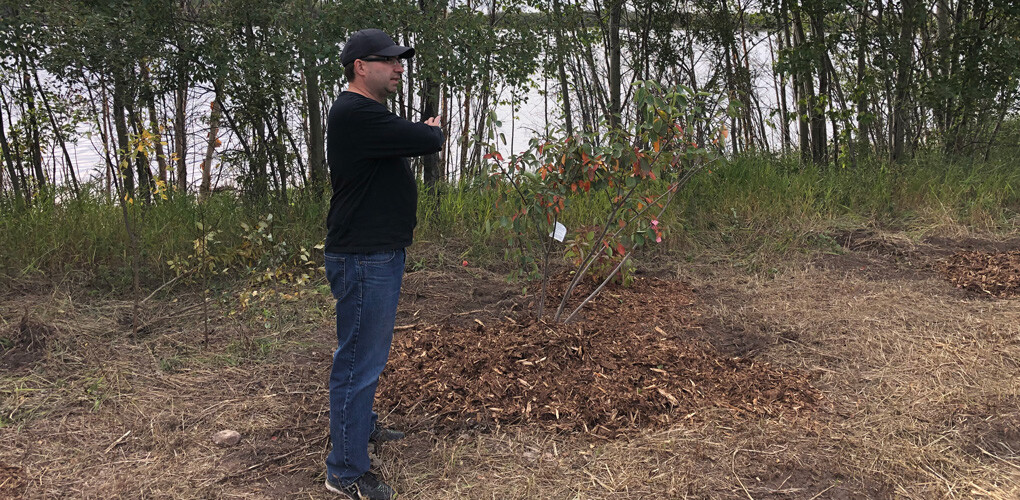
940;251;1020;297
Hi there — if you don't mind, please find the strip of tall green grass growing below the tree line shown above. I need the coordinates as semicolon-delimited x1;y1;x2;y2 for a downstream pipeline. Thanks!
0;155;1020;286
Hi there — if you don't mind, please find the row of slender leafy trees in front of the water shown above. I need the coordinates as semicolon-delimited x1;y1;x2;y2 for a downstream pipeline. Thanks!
0;0;1020;206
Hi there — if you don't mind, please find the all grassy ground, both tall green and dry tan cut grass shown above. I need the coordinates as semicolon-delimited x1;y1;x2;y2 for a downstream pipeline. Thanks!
0;154;1020;500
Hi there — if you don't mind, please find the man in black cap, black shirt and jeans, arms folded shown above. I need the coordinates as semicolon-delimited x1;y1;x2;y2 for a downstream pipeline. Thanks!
325;30;443;499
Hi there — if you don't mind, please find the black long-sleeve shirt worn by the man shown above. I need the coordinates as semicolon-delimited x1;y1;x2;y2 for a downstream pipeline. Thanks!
325;92;443;253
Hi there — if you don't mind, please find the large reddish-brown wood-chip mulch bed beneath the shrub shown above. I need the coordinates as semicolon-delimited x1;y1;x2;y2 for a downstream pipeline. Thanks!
376;279;820;435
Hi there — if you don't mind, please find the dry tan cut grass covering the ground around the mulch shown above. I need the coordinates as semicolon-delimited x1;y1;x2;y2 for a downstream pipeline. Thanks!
0;234;1020;500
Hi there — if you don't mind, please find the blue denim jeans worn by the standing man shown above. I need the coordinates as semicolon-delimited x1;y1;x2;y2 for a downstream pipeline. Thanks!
325;249;404;485
